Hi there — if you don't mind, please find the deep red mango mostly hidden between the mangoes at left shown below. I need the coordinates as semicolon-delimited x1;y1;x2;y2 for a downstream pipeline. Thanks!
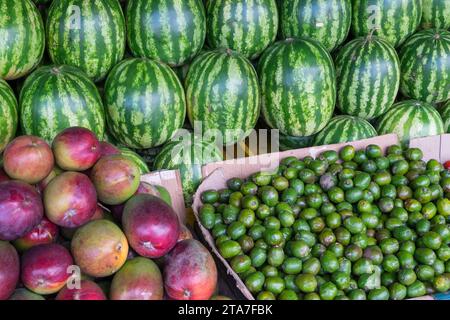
13;217;59;252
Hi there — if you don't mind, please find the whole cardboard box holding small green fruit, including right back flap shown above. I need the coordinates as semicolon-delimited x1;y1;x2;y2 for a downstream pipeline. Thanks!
193;134;450;300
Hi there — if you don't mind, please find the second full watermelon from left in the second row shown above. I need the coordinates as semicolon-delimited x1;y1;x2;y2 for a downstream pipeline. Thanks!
105;58;186;149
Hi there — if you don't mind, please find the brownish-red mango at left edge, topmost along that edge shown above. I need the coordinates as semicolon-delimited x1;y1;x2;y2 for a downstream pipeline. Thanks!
3;136;55;184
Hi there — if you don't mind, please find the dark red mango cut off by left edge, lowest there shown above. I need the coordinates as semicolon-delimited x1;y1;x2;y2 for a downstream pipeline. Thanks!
0;241;20;300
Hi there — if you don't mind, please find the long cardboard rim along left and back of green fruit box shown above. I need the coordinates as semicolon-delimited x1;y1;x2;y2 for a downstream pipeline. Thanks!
192;134;399;300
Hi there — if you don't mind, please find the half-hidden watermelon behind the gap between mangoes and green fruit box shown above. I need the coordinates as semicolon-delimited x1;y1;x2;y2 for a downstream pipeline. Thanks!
153;134;222;206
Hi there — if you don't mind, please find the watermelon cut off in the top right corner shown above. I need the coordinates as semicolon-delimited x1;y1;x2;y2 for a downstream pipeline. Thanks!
422;0;450;29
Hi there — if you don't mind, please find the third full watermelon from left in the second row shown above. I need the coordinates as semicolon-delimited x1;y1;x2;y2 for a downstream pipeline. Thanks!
185;49;261;144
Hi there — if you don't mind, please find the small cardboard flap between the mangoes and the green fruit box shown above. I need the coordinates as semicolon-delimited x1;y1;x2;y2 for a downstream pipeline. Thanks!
141;170;186;224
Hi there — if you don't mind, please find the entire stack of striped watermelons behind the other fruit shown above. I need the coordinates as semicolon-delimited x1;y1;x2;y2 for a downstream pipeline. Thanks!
0;0;450;205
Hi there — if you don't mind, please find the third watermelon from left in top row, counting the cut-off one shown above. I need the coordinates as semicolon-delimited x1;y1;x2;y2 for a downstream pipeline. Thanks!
127;0;206;66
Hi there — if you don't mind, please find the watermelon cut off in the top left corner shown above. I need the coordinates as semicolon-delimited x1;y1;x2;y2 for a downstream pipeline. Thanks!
0;0;45;80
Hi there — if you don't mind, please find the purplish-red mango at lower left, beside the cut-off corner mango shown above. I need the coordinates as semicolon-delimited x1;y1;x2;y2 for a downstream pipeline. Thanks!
21;244;73;295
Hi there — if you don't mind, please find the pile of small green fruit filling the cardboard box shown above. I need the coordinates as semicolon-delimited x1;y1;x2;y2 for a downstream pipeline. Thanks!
199;145;450;300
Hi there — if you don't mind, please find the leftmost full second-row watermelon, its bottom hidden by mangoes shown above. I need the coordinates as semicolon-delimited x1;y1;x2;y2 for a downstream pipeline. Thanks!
19;65;105;143
